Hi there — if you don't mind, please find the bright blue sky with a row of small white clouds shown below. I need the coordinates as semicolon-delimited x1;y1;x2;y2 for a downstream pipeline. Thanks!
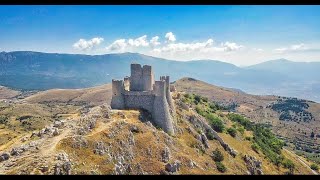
0;5;320;66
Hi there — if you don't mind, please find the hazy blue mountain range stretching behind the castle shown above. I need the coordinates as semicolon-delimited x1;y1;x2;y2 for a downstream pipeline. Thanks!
0;51;320;102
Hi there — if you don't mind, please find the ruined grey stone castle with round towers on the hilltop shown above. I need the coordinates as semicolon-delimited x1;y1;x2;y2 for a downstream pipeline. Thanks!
111;64;175;134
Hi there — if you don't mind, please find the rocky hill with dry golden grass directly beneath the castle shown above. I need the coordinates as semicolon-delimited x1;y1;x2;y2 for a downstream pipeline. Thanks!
0;89;317;174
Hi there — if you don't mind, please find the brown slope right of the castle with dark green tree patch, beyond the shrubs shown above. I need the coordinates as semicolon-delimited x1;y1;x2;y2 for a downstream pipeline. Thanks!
174;78;320;160
